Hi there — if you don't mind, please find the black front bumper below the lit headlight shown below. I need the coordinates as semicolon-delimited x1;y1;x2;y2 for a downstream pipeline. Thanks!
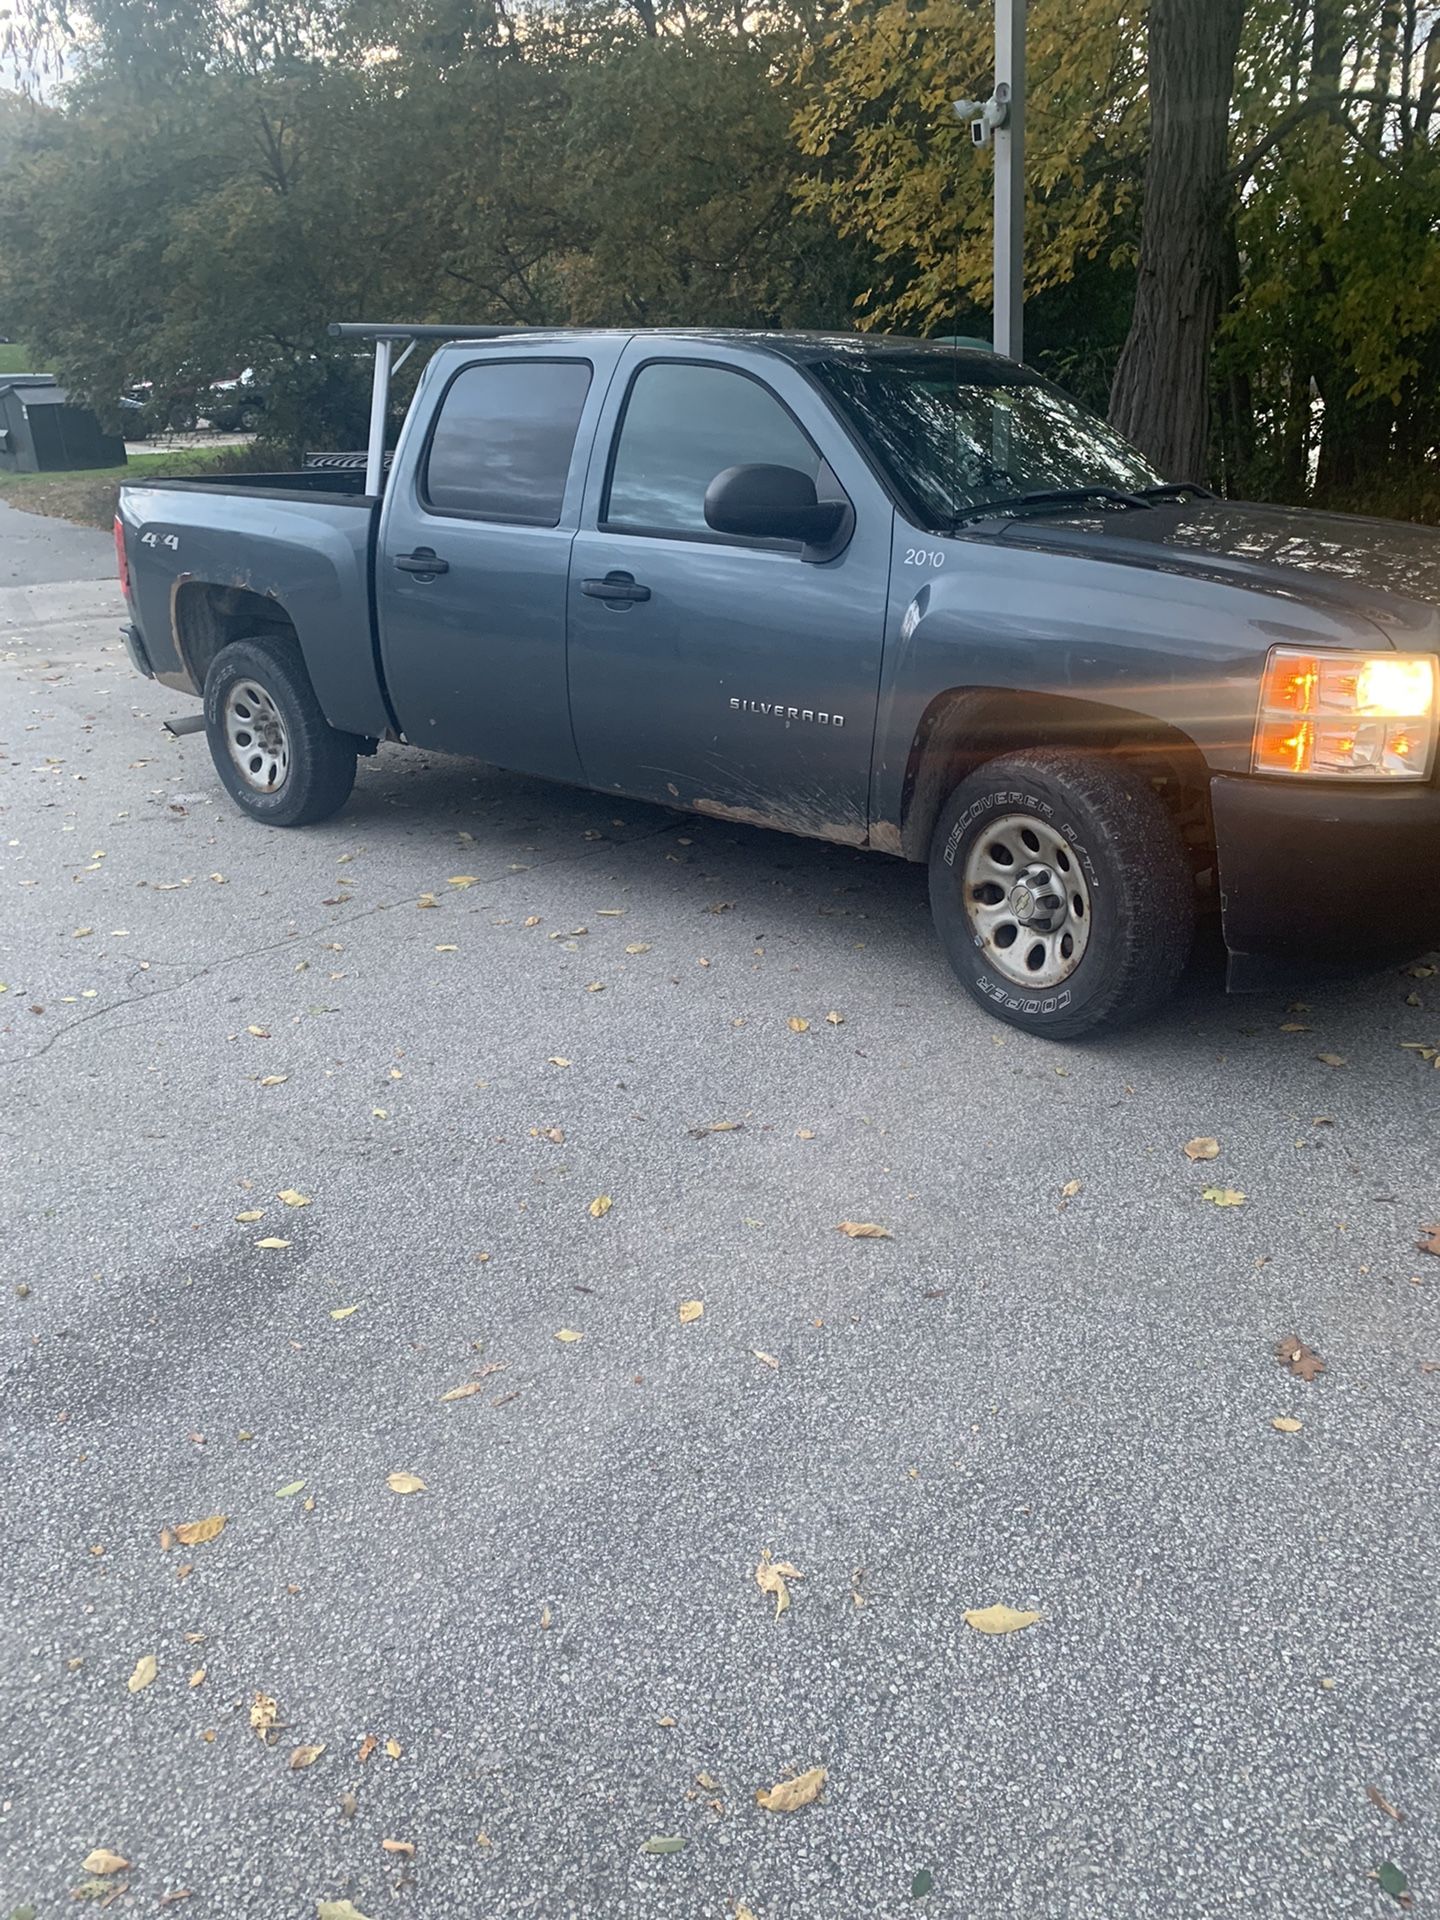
1210;776;1440;989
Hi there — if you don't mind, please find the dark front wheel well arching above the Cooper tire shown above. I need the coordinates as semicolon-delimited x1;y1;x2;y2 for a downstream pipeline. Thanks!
900;687;1215;874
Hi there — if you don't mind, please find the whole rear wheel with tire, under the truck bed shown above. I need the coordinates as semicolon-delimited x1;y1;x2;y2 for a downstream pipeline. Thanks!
205;634;355;828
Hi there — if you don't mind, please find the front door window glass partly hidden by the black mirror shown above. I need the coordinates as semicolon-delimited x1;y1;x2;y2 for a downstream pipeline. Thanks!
601;361;820;540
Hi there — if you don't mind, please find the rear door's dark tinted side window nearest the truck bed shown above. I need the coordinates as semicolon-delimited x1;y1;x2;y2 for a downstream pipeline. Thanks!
420;359;591;526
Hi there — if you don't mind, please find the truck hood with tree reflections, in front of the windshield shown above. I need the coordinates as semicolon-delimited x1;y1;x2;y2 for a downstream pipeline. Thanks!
991;499;1440;645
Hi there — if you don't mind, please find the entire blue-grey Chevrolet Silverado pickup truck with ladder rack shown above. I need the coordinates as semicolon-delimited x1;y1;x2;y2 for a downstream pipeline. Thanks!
115;326;1440;1039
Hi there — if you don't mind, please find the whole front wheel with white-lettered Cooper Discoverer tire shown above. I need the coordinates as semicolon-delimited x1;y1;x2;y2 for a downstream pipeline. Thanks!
929;749;1194;1041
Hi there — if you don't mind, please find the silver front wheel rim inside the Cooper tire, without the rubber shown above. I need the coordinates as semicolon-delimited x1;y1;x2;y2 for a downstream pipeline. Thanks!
962;814;1091;987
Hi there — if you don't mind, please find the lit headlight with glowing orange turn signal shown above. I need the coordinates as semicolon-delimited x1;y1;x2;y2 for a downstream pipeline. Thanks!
1250;647;1440;780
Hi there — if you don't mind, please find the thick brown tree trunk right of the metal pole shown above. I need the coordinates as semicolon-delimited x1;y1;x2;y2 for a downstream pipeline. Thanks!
1110;0;1244;480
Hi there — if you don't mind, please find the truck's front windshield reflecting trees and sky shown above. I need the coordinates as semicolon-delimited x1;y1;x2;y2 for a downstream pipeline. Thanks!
810;348;1162;526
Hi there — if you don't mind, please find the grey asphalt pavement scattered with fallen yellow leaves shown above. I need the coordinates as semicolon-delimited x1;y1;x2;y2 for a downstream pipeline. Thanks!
0;509;1440;1920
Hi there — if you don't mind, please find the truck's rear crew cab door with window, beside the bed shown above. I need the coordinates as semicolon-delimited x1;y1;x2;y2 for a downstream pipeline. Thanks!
374;342;620;780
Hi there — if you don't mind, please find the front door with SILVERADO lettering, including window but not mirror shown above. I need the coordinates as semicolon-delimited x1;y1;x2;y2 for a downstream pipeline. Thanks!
568;349;893;845
